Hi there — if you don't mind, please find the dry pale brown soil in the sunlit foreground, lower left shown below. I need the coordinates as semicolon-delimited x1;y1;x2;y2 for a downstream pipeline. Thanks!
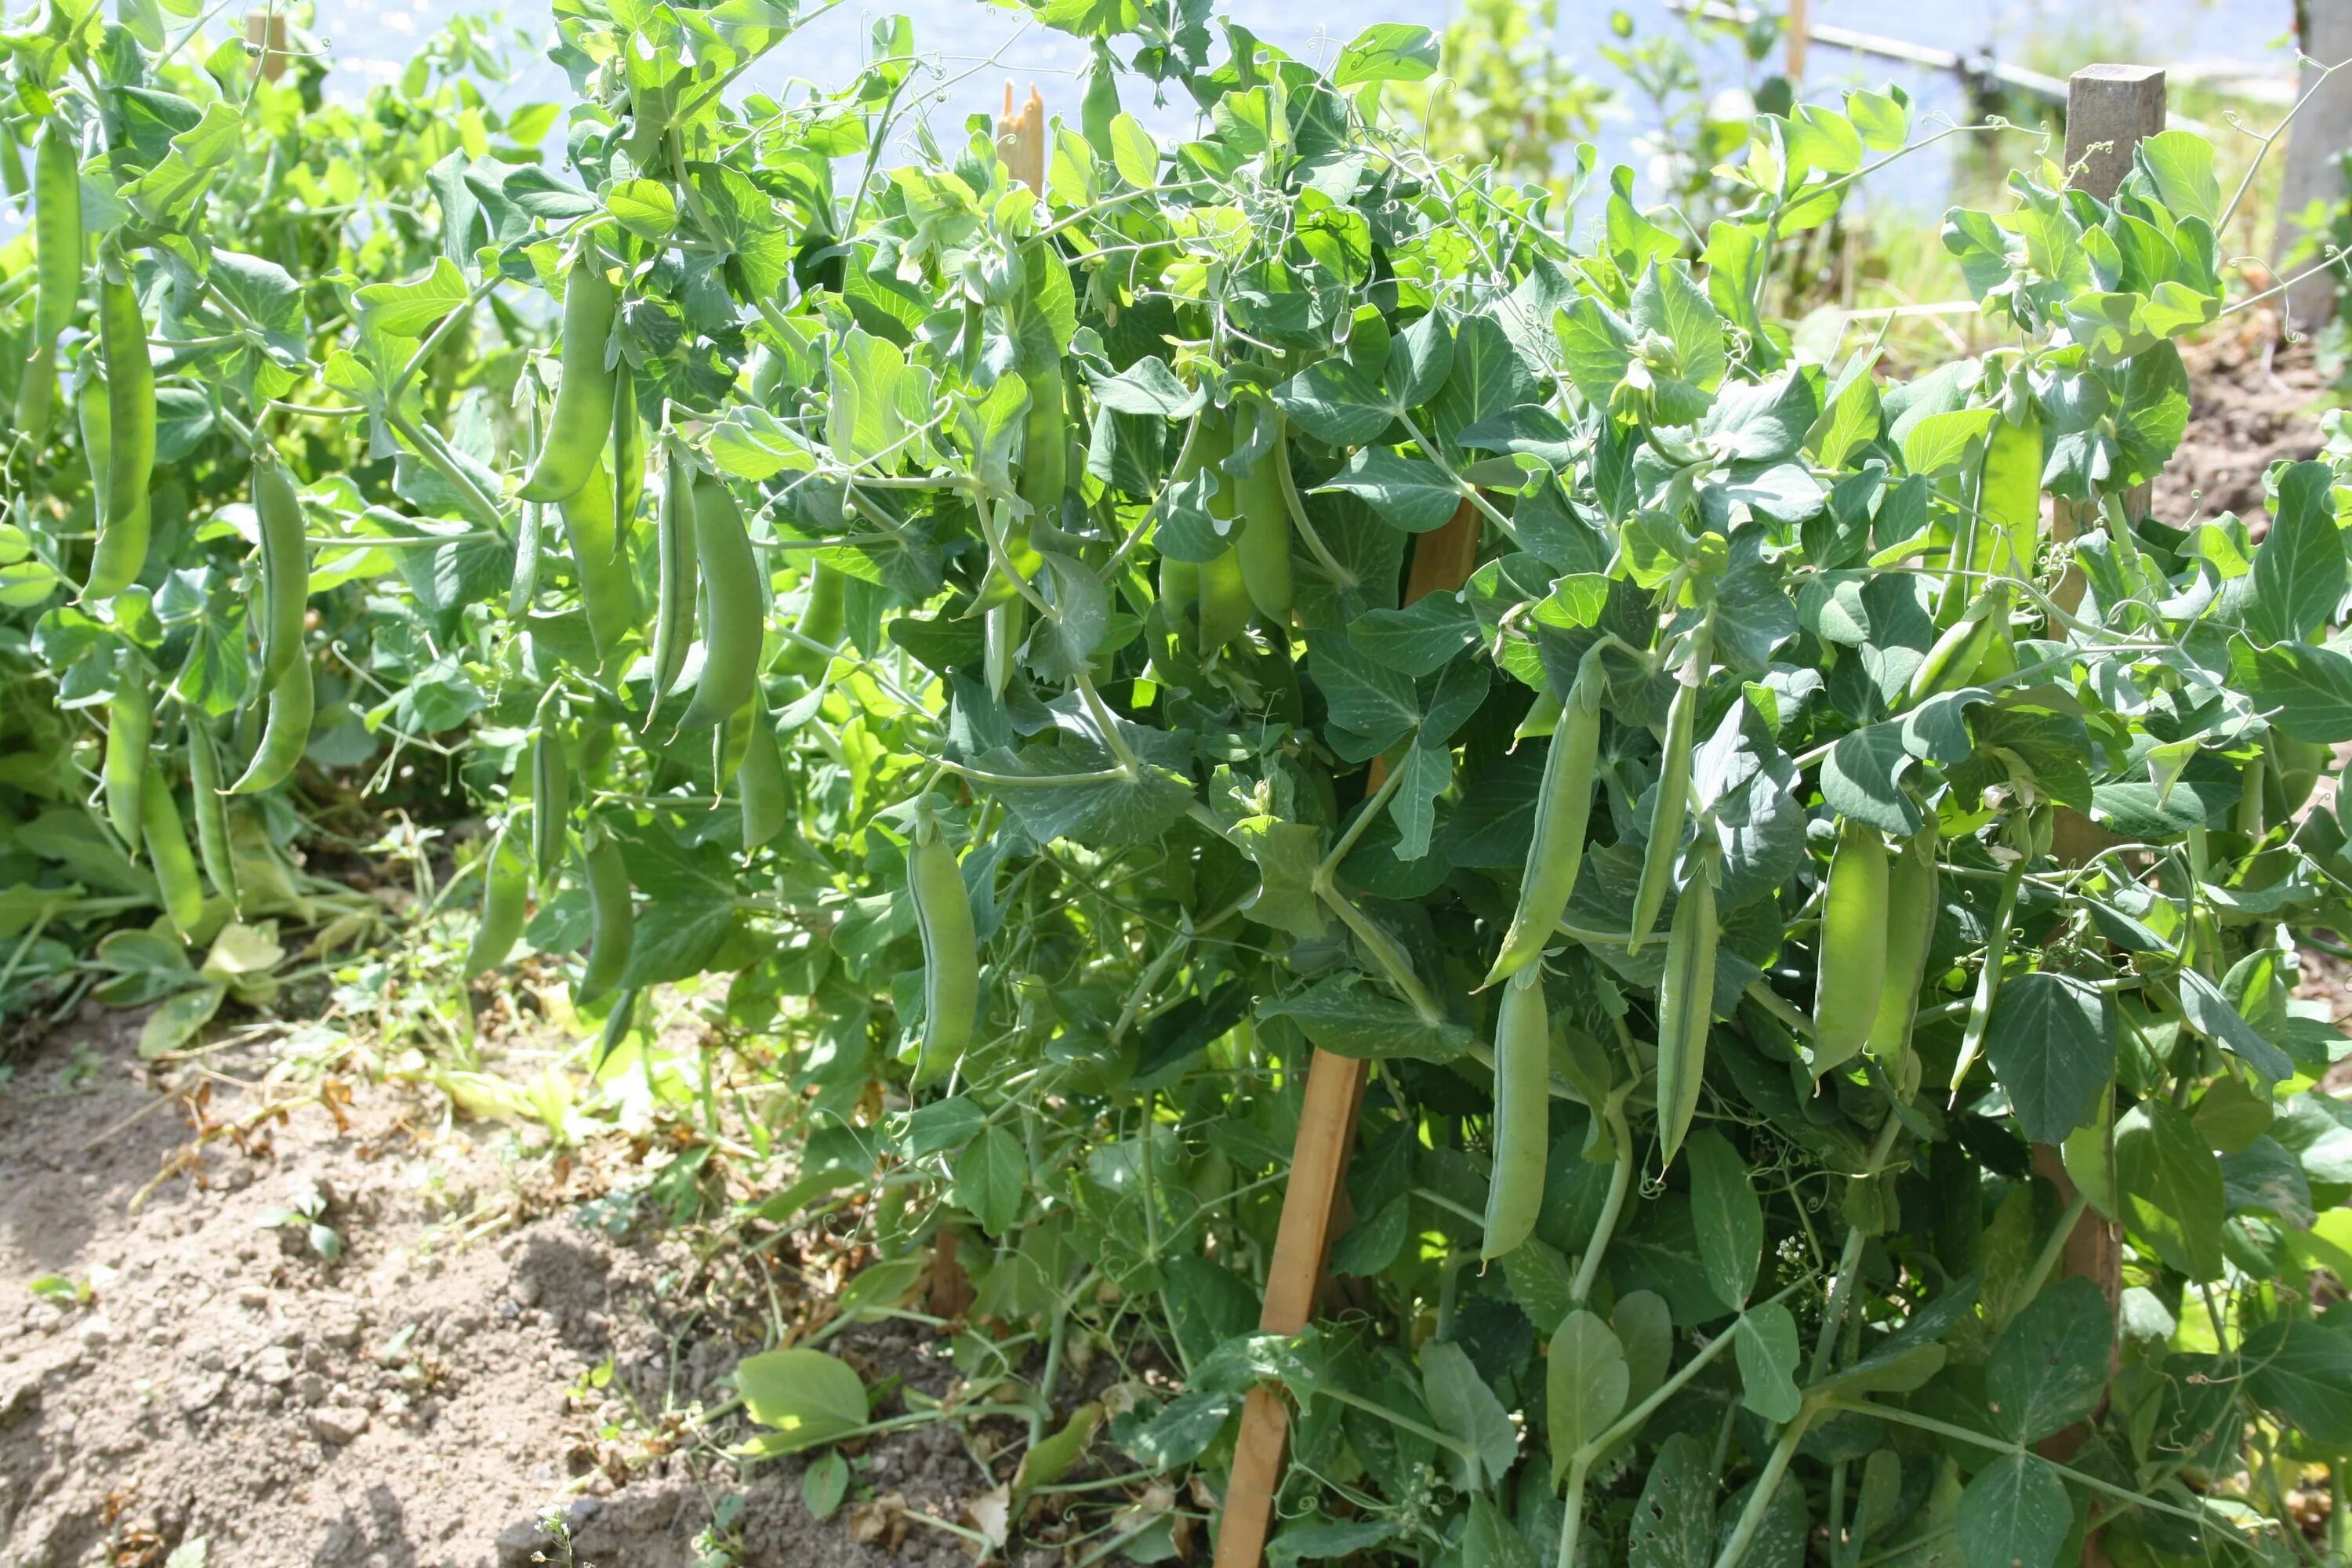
0;1008;993;1568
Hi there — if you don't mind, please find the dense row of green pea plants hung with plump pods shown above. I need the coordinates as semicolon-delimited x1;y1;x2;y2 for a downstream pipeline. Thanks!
0;0;2352;1568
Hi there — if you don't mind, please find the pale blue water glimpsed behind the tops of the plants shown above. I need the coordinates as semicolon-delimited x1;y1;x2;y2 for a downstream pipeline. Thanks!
303;0;2293;207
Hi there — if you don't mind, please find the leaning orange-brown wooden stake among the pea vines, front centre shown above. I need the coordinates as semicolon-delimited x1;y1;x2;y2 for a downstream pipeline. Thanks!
1216;501;1484;1568
